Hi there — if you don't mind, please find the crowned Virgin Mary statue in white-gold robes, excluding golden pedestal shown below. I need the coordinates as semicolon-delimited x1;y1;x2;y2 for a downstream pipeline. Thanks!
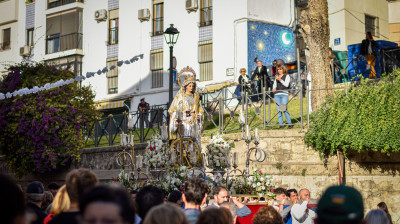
168;66;204;146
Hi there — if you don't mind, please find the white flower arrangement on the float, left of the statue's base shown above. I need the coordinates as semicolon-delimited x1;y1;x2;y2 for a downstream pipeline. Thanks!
144;135;170;168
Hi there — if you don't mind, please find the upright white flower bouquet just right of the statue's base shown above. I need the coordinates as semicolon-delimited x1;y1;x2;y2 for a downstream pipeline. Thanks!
206;136;231;169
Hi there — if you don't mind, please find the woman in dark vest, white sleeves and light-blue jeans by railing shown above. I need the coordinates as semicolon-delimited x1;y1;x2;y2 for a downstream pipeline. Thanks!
272;64;293;129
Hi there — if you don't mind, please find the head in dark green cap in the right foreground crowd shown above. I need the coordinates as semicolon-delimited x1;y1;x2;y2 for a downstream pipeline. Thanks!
316;186;364;224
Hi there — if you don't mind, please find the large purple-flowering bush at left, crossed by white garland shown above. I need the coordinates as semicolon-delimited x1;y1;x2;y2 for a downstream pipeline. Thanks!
0;63;98;176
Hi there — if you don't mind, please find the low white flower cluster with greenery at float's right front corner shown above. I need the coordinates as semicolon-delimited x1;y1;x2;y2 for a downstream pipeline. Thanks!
231;168;275;200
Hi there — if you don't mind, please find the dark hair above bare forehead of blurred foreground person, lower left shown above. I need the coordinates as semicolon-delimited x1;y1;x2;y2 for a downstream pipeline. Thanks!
79;185;135;223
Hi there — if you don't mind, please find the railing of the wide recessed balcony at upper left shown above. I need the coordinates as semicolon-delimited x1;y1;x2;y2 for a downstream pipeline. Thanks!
46;33;83;54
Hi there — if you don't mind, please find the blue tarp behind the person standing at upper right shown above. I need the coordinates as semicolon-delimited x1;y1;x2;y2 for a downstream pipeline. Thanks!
347;40;397;81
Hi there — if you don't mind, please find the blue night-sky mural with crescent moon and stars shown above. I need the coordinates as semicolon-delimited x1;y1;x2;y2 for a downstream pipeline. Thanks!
247;21;296;71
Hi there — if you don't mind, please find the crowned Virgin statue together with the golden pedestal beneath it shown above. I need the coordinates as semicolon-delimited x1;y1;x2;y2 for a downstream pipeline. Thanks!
168;66;204;167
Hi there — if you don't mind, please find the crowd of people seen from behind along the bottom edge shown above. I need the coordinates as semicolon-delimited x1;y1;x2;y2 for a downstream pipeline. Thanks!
0;168;392;224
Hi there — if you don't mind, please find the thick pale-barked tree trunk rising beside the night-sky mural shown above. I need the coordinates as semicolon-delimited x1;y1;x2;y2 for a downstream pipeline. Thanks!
299;0;333;111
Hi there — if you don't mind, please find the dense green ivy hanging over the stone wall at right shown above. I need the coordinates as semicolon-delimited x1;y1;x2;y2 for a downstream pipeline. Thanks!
304;70;400;156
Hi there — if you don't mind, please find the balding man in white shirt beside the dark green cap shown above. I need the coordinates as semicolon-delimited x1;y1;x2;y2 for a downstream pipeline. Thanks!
290;189;317;224
